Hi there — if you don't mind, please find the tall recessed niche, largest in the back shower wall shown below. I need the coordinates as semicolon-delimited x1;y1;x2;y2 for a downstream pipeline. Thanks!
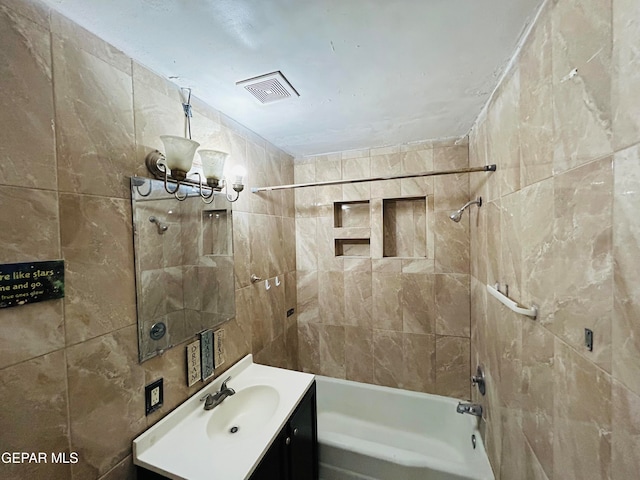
382;197;427;258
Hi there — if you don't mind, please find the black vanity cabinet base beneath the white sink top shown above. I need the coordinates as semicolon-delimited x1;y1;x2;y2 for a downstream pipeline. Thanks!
250;381;318;480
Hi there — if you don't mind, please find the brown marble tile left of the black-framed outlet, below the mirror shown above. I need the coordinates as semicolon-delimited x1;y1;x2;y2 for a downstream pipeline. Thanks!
67;325;147;478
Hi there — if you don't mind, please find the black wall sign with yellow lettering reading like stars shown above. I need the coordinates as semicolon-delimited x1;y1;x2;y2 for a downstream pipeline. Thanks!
0;260;64;308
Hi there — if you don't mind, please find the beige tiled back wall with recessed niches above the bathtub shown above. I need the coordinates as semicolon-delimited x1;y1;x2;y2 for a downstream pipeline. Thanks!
294;138;476;398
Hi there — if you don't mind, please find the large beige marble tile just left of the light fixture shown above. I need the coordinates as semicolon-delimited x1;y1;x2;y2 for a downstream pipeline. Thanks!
52;36;138;198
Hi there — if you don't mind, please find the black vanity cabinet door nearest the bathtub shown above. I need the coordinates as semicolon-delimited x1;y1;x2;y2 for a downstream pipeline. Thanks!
288;382;318;480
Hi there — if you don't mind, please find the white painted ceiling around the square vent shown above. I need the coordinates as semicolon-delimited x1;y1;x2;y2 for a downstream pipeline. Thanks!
41;0;541;155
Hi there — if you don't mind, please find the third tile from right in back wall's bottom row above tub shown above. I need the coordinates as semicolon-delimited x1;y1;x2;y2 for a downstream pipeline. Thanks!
373;328;404;388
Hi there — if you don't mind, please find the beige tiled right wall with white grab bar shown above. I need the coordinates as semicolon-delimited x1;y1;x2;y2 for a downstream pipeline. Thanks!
469;0;640;480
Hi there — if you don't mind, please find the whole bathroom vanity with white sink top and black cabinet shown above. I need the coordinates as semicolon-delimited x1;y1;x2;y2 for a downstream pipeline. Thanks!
133;355;318;480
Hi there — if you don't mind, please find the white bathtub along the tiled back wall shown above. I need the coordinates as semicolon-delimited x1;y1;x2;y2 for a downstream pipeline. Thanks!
316;375;494;480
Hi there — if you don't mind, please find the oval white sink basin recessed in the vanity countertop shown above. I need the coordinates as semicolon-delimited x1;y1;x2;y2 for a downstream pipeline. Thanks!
207;385;280;440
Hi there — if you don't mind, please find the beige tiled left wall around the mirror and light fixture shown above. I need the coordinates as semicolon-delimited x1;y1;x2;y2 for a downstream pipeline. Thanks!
0;0;297;480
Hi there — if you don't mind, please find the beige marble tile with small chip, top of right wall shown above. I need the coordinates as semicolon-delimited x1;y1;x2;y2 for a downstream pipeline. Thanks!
551;0;612;173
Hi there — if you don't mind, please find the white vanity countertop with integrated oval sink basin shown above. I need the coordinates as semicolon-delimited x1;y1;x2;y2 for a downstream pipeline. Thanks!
133;355;314;480
